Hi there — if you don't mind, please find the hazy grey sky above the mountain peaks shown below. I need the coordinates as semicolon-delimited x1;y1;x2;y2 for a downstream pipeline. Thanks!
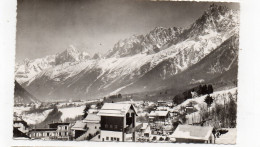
16;0;239;62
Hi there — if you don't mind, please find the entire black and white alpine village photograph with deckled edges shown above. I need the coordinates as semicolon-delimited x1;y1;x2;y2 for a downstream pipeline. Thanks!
12;0;241;145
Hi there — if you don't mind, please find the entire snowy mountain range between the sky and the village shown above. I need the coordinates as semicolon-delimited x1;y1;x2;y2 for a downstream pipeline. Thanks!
15;4;239;101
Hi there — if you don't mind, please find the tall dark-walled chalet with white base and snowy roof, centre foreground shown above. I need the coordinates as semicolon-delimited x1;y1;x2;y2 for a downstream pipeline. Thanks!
98;103;137;142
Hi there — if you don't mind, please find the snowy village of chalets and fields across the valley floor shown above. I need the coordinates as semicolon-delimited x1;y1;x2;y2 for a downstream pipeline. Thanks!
13;88;237;144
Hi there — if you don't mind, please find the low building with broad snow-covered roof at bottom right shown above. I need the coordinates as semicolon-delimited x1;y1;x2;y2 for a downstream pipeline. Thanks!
170;125;215;143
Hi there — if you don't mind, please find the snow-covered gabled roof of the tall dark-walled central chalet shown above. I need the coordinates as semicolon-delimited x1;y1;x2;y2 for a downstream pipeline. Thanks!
97;103;137;116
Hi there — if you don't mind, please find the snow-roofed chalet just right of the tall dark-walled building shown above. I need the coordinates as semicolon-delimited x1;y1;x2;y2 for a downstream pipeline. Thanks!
149;111;169;123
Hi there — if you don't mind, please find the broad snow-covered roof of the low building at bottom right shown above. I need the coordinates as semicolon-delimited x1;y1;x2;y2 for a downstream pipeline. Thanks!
170;125;213;140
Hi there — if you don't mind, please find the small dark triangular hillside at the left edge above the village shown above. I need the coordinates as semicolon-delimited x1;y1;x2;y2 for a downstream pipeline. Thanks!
14;81;39;104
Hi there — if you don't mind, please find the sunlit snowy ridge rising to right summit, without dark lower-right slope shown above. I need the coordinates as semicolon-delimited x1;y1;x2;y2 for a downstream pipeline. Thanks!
16;5;239;99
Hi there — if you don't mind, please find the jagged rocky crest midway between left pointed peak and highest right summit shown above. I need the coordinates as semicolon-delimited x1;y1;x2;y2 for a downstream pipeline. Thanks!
106;27;182;58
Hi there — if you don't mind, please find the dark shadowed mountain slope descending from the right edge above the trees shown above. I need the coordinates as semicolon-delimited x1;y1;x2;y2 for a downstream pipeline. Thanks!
122;34;239;92
